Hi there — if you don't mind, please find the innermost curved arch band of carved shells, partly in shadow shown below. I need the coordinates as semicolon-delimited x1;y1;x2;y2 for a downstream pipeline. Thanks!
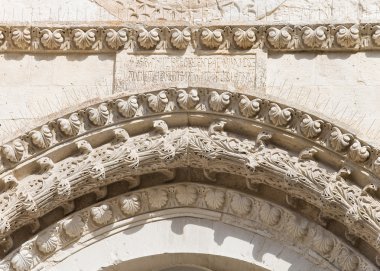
0;183;377;271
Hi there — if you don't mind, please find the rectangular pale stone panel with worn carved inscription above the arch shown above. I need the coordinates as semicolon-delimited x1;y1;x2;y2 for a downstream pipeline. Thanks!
115;52;256;92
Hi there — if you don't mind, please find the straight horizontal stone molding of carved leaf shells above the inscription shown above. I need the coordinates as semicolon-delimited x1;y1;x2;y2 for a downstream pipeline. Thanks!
0;23;380;53
